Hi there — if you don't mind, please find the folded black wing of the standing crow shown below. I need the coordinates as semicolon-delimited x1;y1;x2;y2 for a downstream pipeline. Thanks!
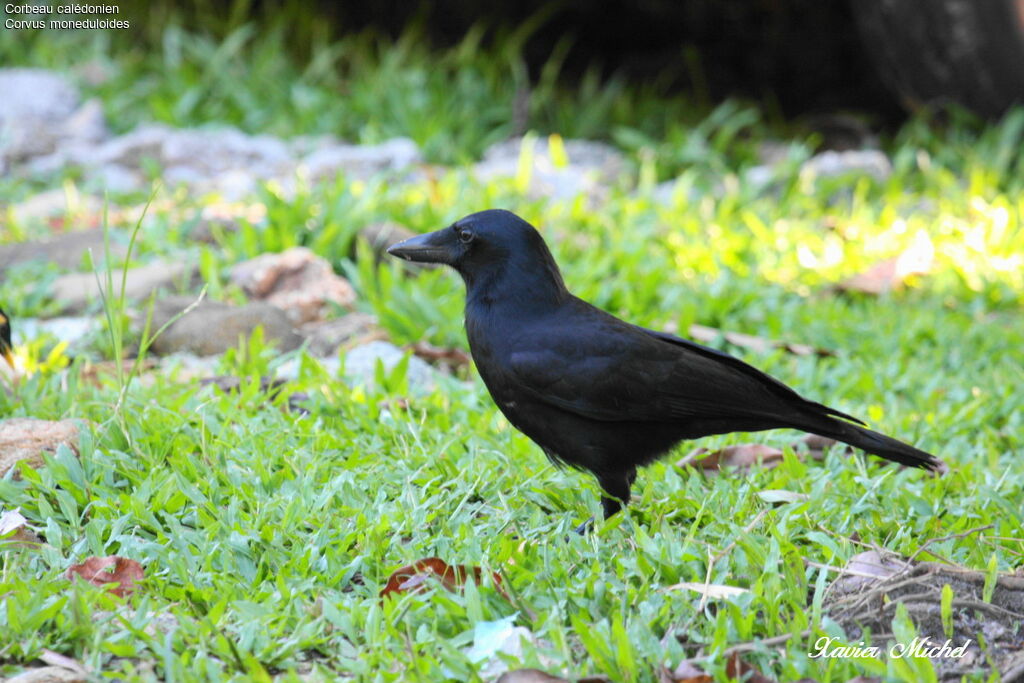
509;301;857;422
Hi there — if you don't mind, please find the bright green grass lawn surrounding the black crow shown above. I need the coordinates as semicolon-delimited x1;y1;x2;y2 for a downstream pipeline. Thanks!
0;14;1024;681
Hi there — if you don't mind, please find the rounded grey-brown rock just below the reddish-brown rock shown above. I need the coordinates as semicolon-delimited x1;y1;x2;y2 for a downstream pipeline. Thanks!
151;297;302;355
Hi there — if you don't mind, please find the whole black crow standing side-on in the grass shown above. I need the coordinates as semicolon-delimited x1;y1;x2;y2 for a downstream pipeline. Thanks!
387;210;943;517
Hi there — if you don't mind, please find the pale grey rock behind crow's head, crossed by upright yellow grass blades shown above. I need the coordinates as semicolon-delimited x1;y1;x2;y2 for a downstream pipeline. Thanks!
473;137;627;199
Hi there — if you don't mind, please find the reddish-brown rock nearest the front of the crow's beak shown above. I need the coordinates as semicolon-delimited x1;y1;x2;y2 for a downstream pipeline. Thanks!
230;247;355;324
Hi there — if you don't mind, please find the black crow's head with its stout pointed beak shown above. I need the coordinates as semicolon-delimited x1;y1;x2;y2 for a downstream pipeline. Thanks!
387;209;564;292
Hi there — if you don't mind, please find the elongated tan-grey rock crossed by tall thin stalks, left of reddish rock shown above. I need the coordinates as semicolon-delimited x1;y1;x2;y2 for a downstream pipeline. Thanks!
52;261;198;313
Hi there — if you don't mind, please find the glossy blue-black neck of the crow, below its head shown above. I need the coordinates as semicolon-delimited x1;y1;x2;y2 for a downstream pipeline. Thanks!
463;256;569;314
